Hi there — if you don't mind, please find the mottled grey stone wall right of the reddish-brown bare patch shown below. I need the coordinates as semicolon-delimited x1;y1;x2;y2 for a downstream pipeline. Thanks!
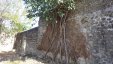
70;0;113;64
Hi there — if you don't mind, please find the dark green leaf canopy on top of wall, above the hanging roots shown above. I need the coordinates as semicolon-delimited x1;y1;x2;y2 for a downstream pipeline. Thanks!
24;0;75;21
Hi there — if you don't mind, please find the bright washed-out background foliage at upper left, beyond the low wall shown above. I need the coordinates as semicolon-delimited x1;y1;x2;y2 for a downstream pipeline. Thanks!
0;0;31;34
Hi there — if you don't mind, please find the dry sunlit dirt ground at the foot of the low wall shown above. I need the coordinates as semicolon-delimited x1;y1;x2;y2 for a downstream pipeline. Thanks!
0;51;54;64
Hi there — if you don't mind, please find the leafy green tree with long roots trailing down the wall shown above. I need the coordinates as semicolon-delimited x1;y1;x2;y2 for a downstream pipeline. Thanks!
24;0;88;64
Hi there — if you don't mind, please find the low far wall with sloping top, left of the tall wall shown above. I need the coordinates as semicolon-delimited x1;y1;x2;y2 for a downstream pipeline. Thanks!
14;27;38;55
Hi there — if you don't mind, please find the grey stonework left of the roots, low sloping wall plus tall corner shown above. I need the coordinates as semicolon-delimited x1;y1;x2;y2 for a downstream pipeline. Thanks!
13;19;46;57
